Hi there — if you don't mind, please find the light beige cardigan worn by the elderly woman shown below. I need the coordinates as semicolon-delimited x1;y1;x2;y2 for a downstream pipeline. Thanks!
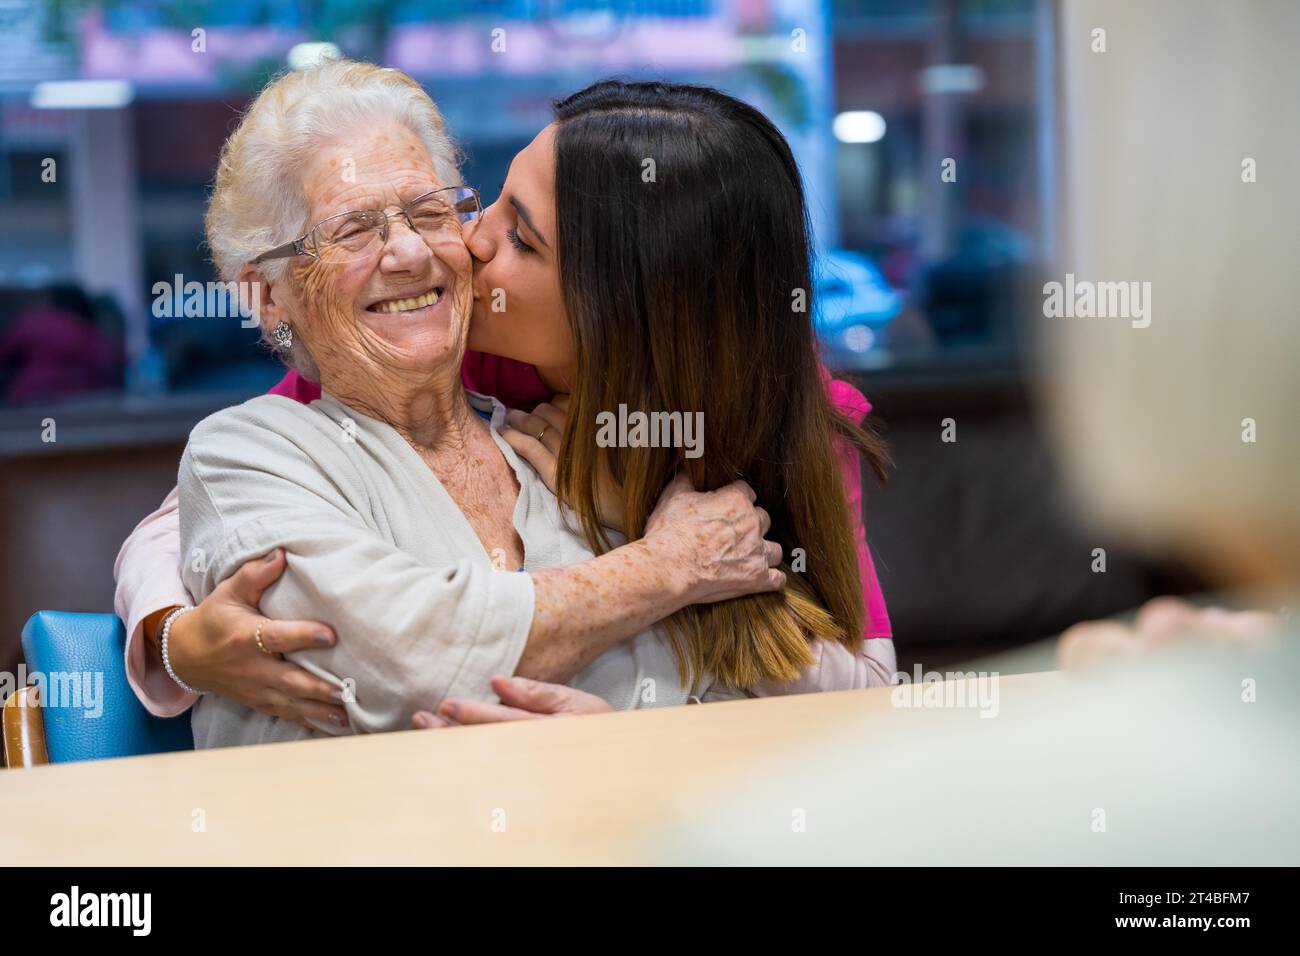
178;393;717;747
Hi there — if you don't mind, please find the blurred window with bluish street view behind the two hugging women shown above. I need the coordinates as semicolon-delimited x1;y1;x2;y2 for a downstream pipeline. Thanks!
0;0;1056;405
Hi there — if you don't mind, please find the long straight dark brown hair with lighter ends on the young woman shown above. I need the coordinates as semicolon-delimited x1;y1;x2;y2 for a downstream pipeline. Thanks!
555;81;887;688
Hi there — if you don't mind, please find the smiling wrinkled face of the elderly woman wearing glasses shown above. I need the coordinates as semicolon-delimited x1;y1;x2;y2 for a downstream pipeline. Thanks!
286;124;471;393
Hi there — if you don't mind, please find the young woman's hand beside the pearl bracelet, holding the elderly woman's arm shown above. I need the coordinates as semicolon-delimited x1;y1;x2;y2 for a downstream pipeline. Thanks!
159;548;347;727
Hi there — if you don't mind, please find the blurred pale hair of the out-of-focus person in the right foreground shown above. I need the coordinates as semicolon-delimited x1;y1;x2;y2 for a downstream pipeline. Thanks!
1040;0;1300;567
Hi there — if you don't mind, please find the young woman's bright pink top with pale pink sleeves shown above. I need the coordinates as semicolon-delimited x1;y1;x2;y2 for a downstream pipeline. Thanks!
113;352;897;717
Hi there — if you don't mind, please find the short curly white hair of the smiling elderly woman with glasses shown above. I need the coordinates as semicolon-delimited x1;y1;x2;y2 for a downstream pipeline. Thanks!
205;60;460;373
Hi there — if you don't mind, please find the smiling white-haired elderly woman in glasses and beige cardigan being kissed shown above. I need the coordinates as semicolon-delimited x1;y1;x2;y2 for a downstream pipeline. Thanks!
172;64;784;747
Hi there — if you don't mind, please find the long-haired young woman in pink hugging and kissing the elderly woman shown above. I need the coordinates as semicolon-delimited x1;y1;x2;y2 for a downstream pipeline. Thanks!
117;72;893;717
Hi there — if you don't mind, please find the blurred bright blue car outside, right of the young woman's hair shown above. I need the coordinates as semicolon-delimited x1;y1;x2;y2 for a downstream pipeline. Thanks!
813;250;904;354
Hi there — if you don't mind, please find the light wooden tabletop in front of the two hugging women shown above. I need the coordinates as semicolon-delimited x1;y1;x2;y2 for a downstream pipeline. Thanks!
0;675;1058;866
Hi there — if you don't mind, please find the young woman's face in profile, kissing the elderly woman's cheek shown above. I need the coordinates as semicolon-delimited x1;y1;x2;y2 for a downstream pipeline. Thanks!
465;124;575;385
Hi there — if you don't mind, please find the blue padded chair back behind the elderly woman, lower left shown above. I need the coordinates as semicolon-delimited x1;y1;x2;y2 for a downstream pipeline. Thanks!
22;611;194;763
